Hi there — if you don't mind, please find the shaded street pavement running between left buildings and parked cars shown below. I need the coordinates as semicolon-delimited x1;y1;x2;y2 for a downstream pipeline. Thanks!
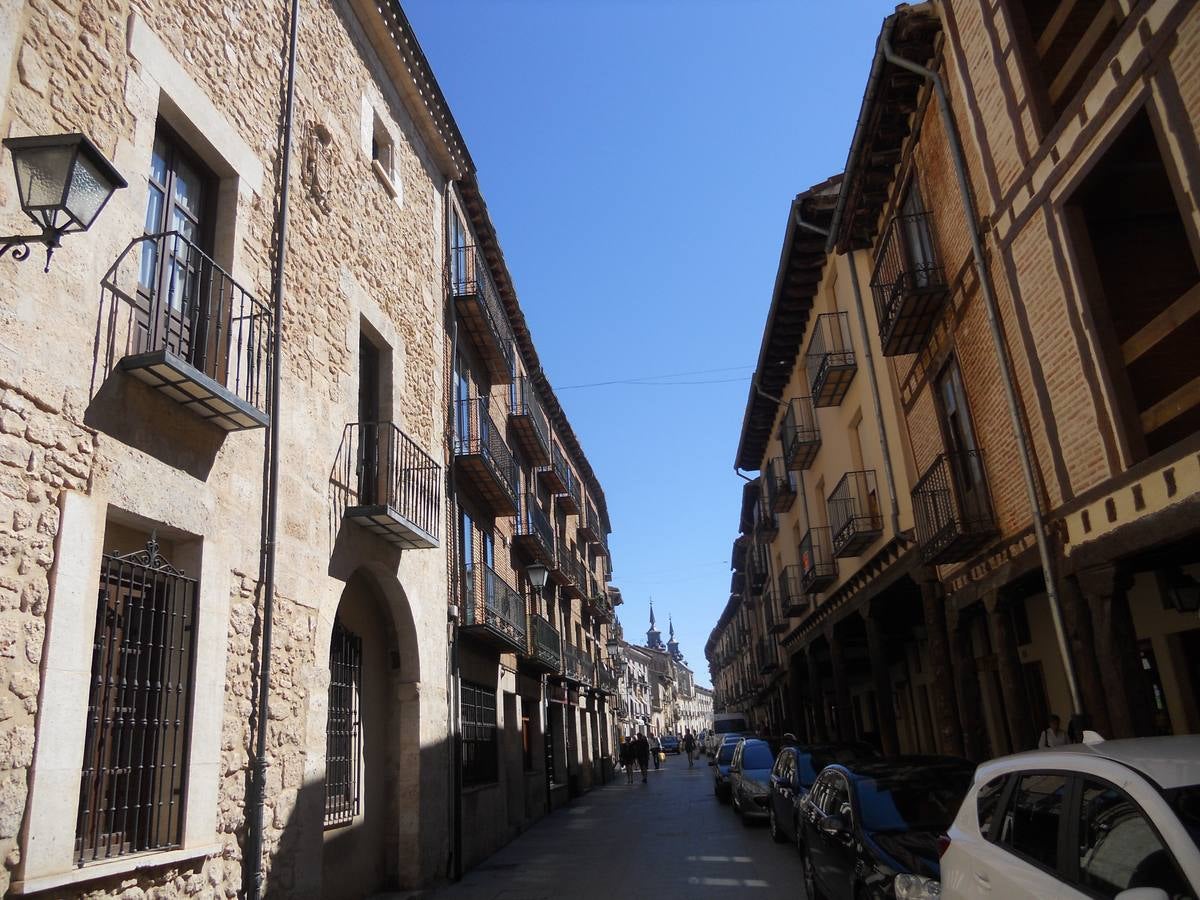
428;756;804;900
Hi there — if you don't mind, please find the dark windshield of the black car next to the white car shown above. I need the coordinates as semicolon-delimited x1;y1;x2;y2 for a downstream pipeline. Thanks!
858;772;971;832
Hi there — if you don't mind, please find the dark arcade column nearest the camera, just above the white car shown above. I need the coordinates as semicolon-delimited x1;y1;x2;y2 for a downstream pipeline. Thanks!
1075;565;1154;738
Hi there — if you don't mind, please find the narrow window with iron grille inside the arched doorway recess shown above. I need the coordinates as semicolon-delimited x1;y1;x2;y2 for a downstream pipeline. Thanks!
325;620;362;828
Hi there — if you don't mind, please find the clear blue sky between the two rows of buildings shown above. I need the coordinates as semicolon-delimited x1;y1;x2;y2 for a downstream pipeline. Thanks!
404;0;895;684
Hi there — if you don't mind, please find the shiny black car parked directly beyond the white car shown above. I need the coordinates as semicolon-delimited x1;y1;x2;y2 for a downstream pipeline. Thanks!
800;756;974;900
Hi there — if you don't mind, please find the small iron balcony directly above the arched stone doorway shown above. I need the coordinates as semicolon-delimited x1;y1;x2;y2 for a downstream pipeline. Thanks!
334;422;442;550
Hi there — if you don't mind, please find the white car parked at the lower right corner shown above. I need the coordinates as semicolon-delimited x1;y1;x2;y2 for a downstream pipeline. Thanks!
941;736;1200;900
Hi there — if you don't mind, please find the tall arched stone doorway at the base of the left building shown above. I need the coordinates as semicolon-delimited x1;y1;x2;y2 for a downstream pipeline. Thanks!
322;572;402;900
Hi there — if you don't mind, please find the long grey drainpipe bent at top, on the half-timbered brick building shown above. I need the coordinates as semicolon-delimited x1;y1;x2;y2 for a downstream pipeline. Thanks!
880;35;1084;715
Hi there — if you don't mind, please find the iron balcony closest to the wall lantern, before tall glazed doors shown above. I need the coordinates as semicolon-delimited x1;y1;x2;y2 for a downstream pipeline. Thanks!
101;232;274;431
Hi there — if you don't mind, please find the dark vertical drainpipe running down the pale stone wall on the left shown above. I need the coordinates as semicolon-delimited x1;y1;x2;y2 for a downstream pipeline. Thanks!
244;0;300;900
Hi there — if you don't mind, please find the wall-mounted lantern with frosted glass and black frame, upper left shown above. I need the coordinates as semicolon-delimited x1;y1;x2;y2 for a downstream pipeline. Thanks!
0;134;127;271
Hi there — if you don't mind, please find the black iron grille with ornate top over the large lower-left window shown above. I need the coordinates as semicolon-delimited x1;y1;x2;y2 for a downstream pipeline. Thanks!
76;536;196;865
